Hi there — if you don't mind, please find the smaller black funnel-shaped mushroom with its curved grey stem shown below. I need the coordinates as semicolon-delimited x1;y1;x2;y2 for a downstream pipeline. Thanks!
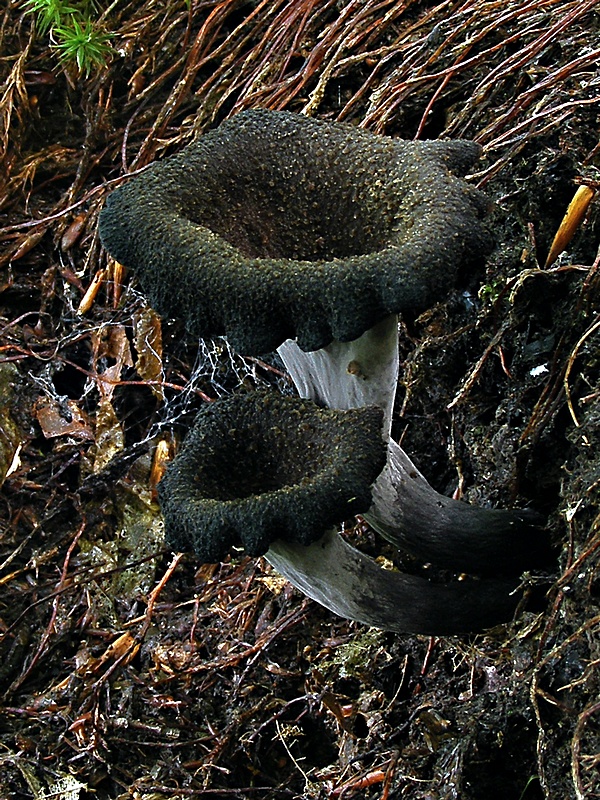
159;392;516;634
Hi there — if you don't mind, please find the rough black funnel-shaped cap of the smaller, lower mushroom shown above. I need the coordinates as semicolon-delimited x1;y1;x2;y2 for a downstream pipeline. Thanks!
158;392;386;562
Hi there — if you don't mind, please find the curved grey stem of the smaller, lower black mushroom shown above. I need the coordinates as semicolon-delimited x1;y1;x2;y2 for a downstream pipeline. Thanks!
266;531;518;635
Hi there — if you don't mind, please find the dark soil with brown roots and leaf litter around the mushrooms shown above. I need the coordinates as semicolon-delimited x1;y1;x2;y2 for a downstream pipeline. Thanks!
0;0;600;800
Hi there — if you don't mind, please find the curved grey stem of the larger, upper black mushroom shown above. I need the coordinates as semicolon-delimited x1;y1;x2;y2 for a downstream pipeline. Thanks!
278;315;544;574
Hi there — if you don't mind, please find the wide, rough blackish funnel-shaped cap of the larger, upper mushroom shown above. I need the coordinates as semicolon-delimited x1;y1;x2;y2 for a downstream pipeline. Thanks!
100;110;489;355
